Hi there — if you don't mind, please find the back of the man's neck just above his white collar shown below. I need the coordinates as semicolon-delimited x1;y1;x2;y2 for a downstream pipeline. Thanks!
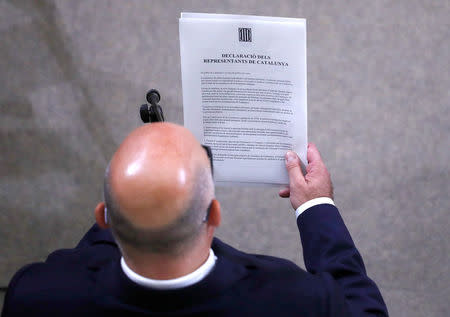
123;241;209;280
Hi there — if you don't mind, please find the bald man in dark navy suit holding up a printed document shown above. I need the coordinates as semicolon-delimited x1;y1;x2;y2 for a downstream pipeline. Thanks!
3;123;387;316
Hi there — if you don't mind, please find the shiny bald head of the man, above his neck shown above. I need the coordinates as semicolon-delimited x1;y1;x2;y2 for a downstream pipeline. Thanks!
105;123;214;252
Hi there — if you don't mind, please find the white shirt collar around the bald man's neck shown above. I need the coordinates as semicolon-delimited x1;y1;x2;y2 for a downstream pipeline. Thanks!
120;249;217;290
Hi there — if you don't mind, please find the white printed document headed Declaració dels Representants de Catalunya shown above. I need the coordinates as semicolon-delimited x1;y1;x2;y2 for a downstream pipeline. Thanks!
179;13;308;185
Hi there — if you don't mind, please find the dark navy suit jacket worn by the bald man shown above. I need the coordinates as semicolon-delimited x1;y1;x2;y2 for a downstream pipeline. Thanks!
2;204;387;317
